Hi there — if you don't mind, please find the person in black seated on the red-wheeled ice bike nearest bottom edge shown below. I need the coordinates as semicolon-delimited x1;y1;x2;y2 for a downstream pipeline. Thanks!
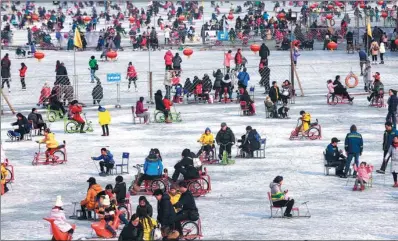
174;182;199;235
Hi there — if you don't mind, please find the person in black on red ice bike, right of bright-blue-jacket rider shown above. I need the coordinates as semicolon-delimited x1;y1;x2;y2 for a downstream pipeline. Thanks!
172;149;199;182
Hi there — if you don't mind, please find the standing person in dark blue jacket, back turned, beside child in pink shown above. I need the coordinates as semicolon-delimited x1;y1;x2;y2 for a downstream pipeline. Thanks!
343;125;363;178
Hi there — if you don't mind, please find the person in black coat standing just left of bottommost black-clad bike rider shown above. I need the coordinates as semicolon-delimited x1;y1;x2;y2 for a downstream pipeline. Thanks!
153;189;176;236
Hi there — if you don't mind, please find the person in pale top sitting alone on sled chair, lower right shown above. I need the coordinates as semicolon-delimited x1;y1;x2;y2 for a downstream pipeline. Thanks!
269;176;294;218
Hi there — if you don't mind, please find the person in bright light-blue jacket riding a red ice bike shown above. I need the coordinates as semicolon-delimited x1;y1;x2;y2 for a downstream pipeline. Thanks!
133;149;163;192
